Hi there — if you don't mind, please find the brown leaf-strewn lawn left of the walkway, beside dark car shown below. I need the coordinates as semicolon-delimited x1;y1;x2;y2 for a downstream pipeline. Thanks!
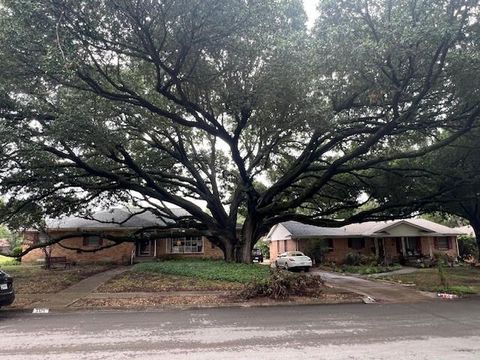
2;265;110;295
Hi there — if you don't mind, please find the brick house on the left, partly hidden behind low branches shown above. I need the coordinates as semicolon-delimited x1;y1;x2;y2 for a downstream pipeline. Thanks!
22;209;223;264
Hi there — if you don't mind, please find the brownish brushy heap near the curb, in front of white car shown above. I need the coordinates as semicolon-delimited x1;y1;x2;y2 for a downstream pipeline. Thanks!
240;269;324;299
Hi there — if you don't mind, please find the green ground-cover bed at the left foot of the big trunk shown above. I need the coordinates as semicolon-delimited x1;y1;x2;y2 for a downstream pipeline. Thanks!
132;260;269;284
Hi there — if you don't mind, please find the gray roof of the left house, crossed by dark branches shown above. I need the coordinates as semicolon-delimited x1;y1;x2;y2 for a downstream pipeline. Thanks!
46;208;188;230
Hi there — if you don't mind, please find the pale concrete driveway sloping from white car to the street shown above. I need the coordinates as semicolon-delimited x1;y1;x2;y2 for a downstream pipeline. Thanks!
311;269;435;303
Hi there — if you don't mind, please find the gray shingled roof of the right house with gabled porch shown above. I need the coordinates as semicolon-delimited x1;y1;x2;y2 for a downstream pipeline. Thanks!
281;219;461;238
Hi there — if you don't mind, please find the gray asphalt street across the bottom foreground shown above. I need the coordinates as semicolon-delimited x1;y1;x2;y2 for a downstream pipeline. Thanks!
0;299;480;360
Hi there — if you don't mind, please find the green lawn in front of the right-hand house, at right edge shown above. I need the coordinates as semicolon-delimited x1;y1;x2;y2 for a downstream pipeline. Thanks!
388;266;480;295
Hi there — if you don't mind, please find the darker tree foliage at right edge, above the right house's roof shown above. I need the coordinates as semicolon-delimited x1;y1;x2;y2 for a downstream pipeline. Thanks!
371;128;480;256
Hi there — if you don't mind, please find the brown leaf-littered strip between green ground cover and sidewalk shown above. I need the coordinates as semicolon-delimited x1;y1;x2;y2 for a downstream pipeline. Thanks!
96;271;243;293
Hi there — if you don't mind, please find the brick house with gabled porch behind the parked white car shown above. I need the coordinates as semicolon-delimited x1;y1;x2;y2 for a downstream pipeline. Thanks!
266;219;460;264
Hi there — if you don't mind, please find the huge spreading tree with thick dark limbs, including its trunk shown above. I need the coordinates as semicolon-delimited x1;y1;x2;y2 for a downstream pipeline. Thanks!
0;0;480;261
